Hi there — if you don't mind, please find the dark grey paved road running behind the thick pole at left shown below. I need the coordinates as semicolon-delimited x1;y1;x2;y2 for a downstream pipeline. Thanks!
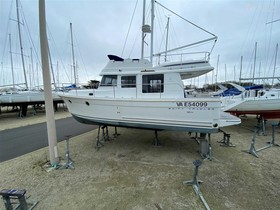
0;117;97;162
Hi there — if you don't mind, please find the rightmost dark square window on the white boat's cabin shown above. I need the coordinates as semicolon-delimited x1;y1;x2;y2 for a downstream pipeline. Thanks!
142;74;164;93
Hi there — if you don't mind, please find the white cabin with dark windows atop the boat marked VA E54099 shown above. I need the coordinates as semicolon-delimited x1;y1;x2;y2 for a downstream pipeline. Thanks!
94;56;185;98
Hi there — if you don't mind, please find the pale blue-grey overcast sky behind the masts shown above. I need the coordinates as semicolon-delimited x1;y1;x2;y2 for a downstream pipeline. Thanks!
0;0;280;86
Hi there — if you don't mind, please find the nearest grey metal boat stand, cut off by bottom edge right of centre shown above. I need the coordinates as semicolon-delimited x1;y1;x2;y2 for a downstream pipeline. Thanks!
183;160;210;210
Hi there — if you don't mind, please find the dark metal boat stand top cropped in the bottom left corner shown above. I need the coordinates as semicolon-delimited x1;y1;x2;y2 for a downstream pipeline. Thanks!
0;189;38;210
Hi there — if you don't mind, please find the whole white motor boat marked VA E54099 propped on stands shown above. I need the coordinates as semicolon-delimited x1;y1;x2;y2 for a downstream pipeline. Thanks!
59;1;241;133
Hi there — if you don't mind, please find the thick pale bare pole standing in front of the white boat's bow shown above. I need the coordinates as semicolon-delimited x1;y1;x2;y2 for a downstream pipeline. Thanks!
39;0;58;167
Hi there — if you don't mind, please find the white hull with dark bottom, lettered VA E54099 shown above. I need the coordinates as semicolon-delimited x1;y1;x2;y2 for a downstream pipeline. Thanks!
60;95;240;133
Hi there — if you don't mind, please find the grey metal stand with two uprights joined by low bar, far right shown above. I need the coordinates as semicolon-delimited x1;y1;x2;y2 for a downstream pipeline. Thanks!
242;123;280;158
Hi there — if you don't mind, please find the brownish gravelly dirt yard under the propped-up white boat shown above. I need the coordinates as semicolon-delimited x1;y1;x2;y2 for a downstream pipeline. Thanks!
0;108;280;210
